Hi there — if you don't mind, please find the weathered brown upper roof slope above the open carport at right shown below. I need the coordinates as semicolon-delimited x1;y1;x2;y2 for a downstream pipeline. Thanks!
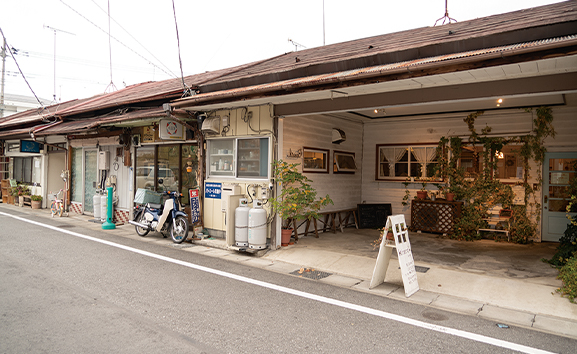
201;1;577;88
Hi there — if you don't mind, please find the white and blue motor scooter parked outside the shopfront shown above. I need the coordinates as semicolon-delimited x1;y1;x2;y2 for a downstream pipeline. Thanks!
129;192;188;243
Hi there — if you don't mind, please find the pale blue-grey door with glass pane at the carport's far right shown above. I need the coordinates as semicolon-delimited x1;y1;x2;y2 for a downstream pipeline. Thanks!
542;152;577;242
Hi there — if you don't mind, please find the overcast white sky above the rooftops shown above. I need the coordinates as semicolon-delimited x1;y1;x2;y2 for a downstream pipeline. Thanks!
0;0;560;102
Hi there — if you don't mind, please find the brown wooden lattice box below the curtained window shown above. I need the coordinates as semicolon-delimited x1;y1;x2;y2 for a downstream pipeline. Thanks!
411;199;463;234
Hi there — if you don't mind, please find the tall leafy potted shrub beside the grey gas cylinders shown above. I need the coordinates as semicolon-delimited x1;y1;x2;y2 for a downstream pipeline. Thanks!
270;160;333;246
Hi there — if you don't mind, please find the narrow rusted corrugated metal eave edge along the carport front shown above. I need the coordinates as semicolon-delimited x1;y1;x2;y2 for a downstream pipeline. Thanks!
172;35;577;108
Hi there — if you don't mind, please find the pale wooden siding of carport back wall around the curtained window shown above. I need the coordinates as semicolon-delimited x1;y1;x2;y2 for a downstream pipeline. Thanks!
361;102;577;224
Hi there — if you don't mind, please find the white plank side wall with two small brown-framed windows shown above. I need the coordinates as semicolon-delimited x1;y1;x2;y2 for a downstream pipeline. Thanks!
279;115;363;211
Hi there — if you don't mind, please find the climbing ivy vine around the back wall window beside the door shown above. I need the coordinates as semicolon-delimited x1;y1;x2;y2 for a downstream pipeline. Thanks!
435;107;555;243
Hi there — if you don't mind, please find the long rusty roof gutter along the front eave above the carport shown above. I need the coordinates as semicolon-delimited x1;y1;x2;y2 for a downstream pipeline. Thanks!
170;35;577;108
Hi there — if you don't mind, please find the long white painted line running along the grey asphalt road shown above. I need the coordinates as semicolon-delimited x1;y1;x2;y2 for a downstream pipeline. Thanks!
0;212;551;353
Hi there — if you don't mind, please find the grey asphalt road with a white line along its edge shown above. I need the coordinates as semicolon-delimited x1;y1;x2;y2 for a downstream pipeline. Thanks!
0;207;577;354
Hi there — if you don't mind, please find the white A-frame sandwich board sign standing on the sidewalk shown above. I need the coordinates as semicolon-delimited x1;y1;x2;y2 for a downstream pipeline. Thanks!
369;214;419;297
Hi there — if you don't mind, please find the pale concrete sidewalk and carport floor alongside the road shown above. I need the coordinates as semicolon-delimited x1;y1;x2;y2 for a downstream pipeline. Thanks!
0;204;577;339
